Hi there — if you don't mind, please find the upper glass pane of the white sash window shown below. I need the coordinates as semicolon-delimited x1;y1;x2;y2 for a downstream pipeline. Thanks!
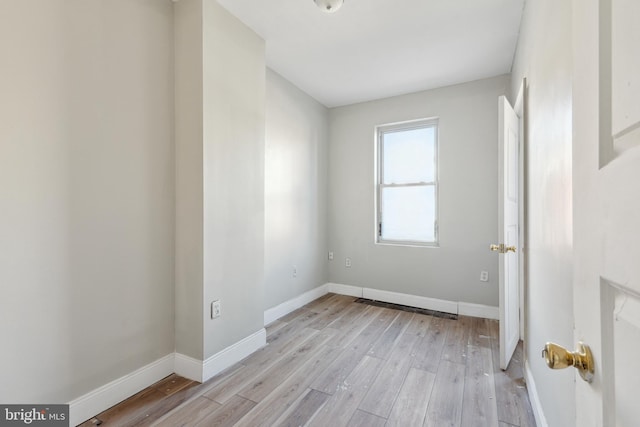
382;126;435;184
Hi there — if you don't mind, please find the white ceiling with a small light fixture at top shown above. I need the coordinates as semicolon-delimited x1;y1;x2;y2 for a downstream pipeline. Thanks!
218;0;525;107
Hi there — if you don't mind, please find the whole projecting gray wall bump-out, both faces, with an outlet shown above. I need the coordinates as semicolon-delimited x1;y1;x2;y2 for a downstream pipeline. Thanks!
175;0;265;360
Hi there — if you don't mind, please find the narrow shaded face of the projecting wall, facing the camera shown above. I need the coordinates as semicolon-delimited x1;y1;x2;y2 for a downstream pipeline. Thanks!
174;0;204;359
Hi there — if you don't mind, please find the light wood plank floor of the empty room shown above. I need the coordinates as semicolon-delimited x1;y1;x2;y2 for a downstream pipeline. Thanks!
82;294;535;427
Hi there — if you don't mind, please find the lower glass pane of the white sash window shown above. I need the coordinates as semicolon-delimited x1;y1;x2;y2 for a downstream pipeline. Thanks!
382;185;436;242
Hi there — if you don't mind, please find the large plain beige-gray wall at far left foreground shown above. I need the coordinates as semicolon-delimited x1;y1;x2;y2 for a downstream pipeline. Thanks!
0;0;174;403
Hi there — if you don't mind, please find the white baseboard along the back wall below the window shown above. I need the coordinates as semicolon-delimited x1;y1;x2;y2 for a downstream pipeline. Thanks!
327;283;499;320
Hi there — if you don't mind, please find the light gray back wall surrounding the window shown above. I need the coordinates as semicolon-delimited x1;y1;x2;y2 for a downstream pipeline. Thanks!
329;76;509;306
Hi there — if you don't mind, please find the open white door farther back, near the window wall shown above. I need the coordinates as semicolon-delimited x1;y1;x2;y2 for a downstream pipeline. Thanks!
492;96;520;369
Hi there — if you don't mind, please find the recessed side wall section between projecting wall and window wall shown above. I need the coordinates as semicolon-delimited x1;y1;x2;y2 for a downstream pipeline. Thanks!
264;69;329;309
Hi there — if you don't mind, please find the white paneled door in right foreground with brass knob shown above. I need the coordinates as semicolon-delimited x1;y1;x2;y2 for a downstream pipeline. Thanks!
567;0;640;427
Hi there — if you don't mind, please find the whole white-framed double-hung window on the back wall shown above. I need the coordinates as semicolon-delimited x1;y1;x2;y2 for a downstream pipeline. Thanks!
376;119;438;246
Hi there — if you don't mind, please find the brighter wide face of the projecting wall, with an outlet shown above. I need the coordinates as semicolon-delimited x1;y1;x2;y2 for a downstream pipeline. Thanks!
204;0;266;359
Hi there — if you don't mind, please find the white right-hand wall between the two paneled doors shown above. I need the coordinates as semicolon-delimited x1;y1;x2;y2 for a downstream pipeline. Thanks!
512;0;575;426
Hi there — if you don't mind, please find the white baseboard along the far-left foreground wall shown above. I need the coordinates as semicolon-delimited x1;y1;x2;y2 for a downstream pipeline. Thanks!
69;353;174;426
